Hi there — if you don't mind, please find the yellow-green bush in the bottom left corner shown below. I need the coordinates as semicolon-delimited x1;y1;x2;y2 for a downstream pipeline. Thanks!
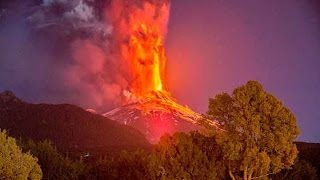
0;131;42;180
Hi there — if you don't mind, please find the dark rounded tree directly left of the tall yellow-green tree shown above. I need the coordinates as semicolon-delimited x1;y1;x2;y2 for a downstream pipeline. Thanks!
151;132;224;179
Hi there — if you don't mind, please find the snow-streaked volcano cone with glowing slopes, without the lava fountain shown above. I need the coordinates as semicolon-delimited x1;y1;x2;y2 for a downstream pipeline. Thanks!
103;91;219;144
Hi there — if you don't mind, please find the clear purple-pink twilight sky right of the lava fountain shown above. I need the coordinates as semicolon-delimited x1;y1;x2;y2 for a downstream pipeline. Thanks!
167;0;320;142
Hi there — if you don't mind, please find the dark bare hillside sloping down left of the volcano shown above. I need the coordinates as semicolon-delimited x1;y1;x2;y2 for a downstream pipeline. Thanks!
0;92;150;152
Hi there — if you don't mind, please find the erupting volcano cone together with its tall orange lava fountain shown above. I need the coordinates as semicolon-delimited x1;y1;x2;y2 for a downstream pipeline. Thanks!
104;1;220;143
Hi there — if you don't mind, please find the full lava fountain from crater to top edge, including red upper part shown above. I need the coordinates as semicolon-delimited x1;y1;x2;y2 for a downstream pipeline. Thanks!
110;0;170;96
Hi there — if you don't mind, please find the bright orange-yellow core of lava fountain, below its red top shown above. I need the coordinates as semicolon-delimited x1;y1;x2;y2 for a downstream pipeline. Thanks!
129;23;166;95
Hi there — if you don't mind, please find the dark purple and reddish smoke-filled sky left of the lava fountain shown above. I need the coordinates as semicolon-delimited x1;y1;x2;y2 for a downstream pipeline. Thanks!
0;0;168;111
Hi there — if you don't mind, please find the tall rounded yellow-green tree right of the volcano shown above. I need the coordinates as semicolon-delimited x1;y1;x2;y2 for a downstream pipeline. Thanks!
207;81;299;179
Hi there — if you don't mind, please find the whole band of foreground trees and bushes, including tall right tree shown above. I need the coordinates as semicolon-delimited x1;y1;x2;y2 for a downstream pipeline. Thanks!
0;81;317;180
